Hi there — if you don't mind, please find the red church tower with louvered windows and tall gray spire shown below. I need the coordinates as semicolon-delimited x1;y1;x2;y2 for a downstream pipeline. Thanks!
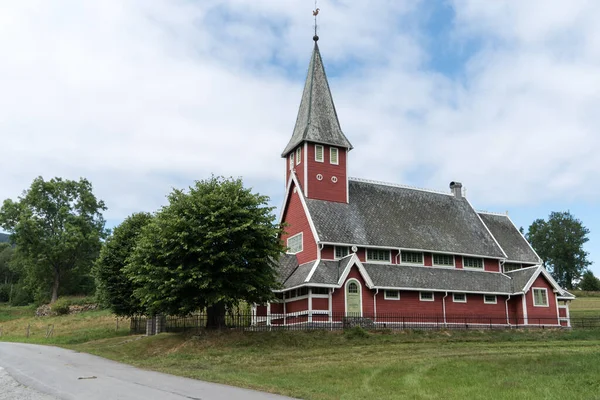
281;35;352;203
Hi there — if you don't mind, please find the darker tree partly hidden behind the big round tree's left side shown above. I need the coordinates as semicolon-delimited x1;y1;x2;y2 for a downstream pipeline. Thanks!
93;213;152;316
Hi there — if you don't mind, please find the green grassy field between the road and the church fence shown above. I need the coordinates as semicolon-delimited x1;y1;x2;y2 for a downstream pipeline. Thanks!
0;299;600;400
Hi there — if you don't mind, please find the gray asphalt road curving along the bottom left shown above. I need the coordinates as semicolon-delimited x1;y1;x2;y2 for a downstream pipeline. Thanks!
0;343;296;400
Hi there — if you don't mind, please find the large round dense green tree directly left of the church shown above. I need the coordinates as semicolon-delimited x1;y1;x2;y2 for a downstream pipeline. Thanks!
127;177;284;327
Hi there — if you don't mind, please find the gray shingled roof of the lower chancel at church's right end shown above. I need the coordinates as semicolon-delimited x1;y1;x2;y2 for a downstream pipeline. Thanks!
479;213;541;264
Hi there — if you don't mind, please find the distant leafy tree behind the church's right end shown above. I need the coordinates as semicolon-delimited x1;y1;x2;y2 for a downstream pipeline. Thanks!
527;211;591;289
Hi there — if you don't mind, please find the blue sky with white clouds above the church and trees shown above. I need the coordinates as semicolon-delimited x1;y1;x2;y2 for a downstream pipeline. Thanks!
0;0;600;276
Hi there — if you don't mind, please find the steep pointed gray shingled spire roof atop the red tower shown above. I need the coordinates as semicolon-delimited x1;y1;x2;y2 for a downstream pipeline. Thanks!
281;42;352;157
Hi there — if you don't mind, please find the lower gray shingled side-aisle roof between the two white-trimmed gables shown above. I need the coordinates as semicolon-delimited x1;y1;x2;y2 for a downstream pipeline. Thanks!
363;263;512;293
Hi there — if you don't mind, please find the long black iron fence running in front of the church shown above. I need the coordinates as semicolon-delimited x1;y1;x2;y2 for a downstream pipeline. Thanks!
130;312;600;334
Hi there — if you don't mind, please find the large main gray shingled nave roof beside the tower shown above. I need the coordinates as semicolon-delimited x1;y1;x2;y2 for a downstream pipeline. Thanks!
306;180;504;258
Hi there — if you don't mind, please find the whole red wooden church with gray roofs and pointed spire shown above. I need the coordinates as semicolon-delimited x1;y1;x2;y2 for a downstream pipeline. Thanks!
257;36;574;327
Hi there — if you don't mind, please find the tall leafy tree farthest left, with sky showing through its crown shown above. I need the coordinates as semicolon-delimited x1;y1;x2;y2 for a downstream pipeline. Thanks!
0;177;106;302
